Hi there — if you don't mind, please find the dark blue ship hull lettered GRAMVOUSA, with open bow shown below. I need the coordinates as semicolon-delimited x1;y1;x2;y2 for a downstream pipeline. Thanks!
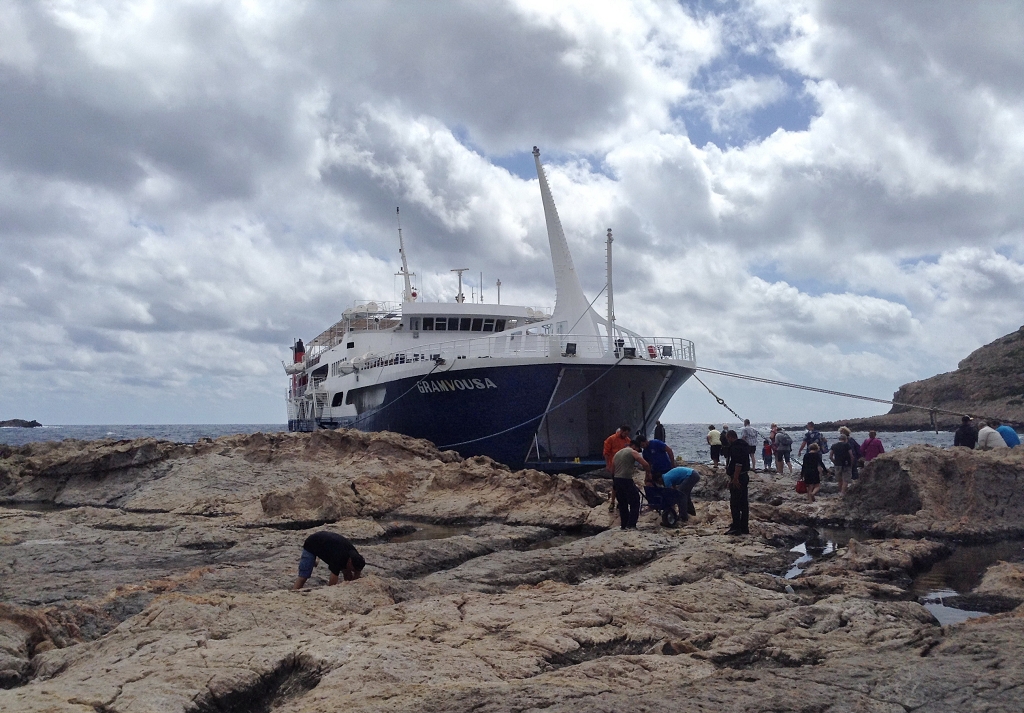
289;361;693;472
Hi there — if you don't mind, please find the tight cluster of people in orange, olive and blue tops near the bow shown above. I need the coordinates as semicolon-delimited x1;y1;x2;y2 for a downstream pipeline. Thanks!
604;421;700;530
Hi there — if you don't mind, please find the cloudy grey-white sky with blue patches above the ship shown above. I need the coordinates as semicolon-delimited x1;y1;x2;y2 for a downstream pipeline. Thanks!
0;0;1024;424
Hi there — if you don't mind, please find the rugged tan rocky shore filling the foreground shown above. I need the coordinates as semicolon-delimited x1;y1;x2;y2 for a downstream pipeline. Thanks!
0;431;1024;713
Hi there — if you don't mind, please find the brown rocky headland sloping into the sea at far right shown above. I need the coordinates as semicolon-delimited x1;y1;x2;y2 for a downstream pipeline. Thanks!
819;327;1024;430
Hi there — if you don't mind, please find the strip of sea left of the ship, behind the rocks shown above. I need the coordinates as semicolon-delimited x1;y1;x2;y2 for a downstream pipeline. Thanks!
0;423;288;446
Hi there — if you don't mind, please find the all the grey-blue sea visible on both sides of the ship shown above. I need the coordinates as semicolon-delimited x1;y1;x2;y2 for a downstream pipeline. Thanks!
0;423;953;463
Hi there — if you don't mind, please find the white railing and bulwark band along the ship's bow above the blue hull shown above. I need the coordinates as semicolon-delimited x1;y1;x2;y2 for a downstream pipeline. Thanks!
353;332;695;370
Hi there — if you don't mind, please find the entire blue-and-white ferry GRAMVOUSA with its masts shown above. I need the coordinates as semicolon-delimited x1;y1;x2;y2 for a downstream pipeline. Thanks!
285;146;696;473
